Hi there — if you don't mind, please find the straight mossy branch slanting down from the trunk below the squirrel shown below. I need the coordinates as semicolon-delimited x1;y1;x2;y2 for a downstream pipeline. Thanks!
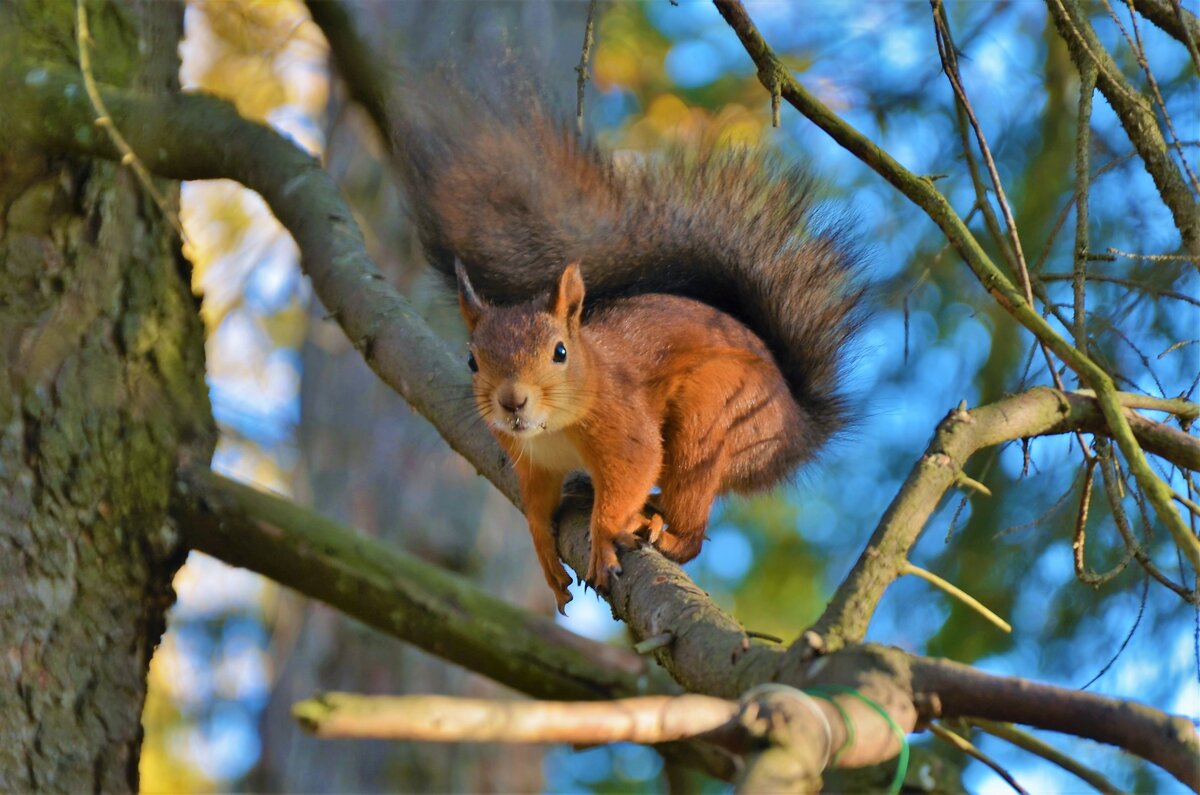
172;470;647;700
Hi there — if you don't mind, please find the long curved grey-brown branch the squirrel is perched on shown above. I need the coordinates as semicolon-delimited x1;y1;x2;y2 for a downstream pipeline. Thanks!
0;66;1194;783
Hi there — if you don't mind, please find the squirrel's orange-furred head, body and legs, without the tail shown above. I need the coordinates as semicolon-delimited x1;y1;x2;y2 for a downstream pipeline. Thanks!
458;265;809;611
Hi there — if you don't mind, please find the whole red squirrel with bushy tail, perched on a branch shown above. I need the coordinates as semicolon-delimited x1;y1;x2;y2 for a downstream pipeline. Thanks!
395;87;862;612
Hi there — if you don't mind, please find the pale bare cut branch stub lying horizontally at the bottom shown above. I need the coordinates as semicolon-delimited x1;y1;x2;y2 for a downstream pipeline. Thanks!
293;685;890;793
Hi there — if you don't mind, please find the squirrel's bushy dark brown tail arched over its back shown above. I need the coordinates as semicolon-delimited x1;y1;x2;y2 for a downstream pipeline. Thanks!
395;85;862;449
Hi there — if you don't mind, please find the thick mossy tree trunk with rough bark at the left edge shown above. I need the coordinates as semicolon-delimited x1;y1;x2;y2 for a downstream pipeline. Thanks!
0;0;215;793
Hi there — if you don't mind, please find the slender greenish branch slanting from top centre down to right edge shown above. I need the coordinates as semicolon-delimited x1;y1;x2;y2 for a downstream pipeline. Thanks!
714;0;1200;578
